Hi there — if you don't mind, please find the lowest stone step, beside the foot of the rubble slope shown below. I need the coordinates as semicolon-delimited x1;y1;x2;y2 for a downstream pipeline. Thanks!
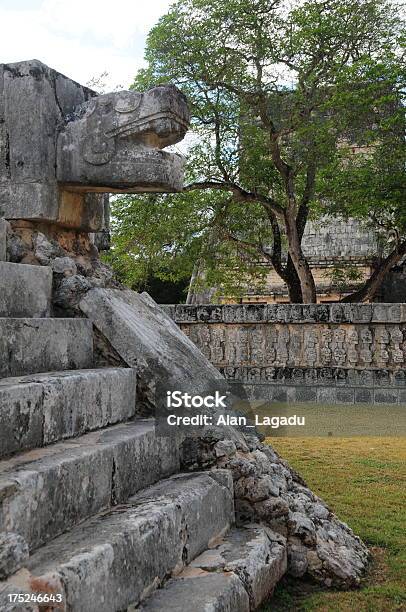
138;525;287;612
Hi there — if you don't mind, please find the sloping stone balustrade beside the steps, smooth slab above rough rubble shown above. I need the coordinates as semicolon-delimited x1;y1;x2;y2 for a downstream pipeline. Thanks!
80;289;368;587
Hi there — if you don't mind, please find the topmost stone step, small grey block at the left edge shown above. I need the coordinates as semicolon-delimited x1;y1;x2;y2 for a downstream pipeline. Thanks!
0;261;52;318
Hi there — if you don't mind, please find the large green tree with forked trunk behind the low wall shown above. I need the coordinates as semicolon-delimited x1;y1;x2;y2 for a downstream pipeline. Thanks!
110;0;401;303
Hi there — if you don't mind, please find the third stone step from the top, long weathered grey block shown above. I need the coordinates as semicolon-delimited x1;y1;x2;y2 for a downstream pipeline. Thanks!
0;368;136;458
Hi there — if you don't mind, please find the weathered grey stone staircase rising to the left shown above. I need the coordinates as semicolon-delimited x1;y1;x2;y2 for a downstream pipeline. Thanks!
0;262;286;612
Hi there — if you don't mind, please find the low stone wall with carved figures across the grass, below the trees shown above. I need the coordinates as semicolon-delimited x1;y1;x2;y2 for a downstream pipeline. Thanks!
166;304;406;403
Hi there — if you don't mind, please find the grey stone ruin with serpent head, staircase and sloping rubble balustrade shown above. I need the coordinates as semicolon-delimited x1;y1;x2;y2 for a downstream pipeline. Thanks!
0;61;368;612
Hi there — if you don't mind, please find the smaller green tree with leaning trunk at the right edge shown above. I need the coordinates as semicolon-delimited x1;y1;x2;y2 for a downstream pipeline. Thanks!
320;58;406;302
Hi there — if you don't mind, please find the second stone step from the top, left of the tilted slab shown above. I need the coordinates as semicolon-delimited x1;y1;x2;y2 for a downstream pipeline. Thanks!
0;318;93;378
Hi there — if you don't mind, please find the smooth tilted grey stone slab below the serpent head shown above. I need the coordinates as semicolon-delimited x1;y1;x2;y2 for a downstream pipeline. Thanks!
80;289;223;404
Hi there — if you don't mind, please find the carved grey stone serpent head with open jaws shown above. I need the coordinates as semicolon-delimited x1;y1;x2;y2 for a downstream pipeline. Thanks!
57;85;190;191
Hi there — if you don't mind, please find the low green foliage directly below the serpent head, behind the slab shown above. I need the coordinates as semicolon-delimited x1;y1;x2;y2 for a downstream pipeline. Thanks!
105;191;272;295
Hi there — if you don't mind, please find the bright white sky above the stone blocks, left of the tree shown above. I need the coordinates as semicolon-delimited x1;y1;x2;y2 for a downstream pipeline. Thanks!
0;0;171;90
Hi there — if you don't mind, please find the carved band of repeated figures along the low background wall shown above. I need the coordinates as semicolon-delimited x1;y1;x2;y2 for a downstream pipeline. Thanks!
179;320;406;376
